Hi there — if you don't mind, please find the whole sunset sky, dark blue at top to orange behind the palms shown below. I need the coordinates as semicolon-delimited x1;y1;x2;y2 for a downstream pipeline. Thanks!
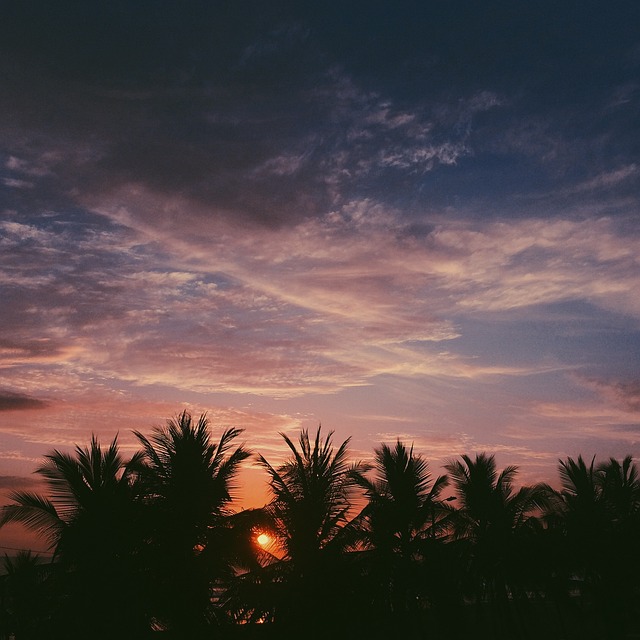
0;0;640;550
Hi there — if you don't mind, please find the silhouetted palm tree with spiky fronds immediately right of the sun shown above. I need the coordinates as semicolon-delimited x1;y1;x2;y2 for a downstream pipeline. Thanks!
258;427;366;628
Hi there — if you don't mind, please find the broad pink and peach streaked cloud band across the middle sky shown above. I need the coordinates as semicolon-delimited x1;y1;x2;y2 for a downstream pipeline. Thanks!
2;190;640;404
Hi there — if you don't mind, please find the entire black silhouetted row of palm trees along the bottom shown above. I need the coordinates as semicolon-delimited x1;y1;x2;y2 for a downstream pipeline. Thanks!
0;412;640;640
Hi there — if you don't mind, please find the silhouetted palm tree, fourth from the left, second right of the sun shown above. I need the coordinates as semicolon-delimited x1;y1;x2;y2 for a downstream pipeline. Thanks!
359;440;450;626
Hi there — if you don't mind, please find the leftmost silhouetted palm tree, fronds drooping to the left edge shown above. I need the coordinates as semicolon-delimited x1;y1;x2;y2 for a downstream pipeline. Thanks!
0;436;146;638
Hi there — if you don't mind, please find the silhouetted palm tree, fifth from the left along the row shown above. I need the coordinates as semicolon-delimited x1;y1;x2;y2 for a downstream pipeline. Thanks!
446;453;550;637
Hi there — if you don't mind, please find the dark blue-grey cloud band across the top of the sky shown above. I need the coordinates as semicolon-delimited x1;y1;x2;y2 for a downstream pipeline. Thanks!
0;0;639;226
